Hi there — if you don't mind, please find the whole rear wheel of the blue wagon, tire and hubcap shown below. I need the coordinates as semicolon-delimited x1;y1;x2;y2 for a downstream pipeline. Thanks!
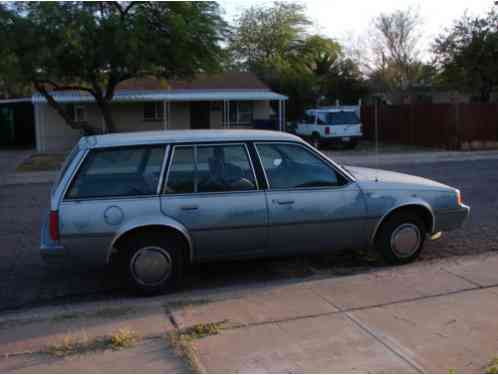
123;231;185;295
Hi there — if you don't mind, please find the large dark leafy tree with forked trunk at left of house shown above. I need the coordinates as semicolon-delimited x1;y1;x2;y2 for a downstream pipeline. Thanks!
0;2;226;133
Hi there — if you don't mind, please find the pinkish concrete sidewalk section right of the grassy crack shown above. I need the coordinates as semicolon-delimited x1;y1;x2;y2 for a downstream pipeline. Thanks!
173;256;498;373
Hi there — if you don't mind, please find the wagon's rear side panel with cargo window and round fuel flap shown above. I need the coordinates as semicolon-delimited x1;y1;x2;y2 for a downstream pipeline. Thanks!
59;145;165;264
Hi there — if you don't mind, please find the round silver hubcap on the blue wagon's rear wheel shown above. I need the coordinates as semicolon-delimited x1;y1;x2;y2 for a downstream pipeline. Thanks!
130;246;173;286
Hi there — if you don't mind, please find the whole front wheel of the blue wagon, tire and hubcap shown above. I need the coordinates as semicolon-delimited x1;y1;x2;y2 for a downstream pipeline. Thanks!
375;212;426;264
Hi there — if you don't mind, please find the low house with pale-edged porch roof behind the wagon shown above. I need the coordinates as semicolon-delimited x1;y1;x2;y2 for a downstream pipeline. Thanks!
32;72;287;152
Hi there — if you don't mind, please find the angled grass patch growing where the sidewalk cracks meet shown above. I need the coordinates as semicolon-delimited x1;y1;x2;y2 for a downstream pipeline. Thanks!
166;321;226;373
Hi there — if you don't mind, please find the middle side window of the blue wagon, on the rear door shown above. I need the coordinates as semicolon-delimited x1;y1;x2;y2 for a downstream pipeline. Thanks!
165;145;257;194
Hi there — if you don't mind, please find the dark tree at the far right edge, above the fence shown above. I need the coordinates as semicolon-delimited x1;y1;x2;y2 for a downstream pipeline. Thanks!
434;10;498;102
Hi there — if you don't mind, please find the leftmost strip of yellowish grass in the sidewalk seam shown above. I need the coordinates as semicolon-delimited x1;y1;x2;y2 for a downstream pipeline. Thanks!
46;328;139;357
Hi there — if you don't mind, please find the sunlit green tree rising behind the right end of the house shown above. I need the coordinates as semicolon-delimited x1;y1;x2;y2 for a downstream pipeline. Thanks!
228;2;366;119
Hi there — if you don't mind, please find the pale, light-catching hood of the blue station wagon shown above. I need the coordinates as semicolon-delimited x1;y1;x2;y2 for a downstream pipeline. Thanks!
346;166;452;190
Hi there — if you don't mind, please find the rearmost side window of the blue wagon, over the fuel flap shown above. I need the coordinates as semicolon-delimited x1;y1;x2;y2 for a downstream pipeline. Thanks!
67;146;164;199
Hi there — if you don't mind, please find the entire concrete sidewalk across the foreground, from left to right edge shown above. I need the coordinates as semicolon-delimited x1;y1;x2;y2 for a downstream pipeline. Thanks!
0;253;498;372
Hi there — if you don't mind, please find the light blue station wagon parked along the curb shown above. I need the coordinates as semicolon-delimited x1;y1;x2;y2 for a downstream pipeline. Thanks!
41;130;470;293
